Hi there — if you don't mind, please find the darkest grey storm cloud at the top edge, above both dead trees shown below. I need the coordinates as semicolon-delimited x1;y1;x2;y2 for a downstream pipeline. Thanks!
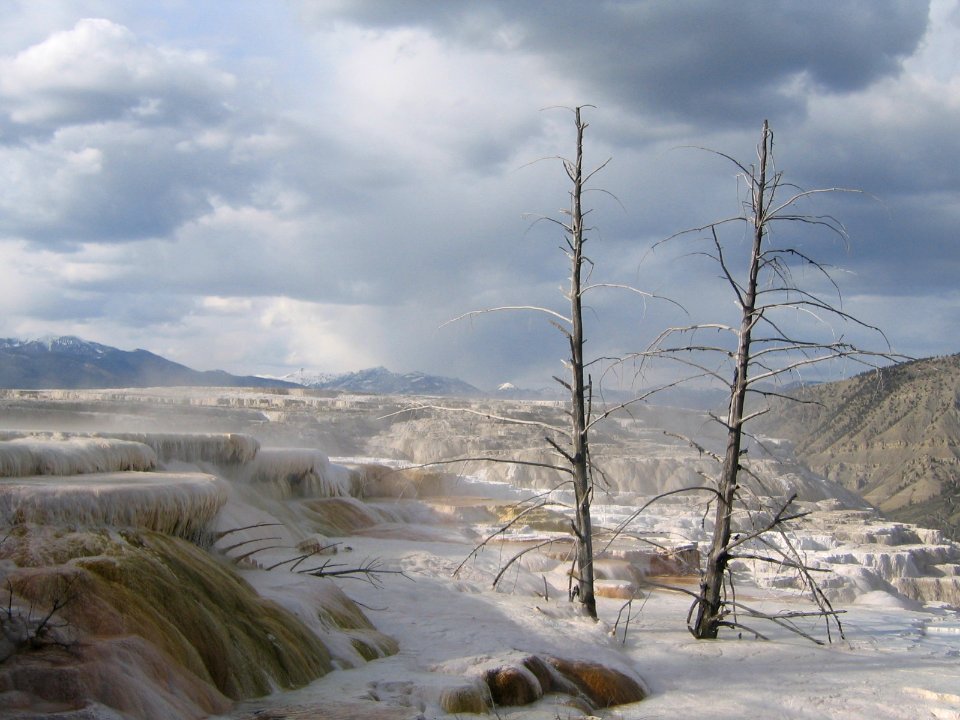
303;0;927;125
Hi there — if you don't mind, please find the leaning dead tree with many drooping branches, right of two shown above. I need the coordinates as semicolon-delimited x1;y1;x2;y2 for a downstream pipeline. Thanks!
641;122;899;638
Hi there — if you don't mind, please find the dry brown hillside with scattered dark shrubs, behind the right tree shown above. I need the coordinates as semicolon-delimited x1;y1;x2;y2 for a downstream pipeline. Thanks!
763;355;960;537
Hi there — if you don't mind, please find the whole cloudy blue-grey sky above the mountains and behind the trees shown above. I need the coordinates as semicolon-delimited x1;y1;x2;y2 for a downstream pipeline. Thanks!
0;0;960;388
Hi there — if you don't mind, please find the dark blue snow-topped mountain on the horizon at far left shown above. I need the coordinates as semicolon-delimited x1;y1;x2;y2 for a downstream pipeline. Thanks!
0;336;296;390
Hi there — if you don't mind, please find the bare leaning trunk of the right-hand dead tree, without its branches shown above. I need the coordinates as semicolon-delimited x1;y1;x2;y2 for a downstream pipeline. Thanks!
693;121;770;639
